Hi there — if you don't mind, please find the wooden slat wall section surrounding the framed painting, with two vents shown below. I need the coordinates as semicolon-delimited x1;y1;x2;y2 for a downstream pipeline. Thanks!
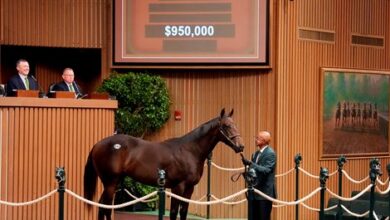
274;0;390;219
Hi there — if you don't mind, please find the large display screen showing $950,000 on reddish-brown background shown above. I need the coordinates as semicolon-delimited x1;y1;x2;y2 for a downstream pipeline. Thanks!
114;0;268;64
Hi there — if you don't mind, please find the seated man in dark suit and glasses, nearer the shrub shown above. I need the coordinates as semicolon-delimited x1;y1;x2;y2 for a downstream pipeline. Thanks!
49;68;83;98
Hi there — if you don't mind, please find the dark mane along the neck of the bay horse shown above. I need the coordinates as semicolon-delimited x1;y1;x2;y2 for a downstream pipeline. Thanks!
164;117;219;142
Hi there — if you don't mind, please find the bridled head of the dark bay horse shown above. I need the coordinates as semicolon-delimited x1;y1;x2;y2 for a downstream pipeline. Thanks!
219;109;244;153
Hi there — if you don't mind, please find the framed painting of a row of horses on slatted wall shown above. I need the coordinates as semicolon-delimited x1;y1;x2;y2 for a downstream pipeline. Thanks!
320;68;390;159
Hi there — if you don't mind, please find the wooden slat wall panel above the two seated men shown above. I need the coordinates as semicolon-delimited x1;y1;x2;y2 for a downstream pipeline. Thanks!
0;0;105;48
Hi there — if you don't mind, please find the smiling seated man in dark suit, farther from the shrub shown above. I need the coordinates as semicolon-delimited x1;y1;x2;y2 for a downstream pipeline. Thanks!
6;59;39;96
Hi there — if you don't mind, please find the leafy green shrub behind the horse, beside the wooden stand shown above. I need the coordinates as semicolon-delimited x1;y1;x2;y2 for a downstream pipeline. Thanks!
98;72;170;211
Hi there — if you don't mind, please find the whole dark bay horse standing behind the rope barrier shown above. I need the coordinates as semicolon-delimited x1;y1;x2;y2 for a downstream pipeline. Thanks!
84;109;244;220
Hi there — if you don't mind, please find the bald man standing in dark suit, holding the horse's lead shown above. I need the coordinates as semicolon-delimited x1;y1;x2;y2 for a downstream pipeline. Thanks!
242;131;276;220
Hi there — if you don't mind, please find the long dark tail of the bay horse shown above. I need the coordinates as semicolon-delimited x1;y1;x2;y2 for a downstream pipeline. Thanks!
84;151;97;208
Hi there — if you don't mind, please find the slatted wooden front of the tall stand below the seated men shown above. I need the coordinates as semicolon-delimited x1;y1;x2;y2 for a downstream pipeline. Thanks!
0;98;115;220
